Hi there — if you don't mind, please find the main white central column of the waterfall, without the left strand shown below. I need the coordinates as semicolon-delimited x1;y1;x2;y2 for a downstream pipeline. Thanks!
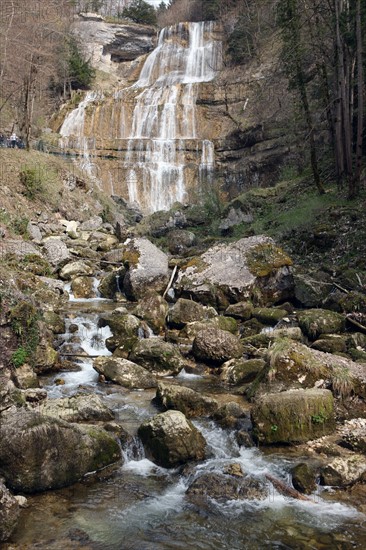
126;22;221;211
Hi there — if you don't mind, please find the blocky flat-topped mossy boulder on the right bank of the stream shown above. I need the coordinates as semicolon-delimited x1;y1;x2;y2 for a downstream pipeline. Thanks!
251;388;335;445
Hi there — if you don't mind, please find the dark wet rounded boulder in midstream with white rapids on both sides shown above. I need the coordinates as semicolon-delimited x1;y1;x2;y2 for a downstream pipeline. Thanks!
138;411;206;468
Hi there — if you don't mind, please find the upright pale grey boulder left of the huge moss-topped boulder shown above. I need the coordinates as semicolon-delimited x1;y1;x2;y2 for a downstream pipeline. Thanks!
123;238;169;300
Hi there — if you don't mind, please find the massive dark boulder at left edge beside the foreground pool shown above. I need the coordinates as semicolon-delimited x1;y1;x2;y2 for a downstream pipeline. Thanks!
0;409;121;493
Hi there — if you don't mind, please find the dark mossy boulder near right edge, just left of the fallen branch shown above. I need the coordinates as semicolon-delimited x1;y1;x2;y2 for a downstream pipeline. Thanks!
297;309;345;340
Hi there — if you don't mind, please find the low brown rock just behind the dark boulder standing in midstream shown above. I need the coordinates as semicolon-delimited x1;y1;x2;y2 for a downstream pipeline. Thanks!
156;382;218;418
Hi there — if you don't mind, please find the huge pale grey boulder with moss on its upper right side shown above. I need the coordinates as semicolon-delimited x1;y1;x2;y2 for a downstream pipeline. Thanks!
175;235;293;307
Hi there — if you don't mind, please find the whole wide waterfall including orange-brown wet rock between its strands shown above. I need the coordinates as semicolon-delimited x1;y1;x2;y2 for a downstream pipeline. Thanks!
60;22;222;212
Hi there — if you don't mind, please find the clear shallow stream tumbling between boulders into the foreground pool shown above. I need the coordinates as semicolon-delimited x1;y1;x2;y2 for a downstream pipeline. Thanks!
7;292;366;550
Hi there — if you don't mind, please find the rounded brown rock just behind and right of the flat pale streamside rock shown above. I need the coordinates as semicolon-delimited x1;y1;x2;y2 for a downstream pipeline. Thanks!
128;338;187;376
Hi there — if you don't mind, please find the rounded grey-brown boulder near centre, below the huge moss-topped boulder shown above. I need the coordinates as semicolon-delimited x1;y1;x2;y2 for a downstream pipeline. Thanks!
192;327;243;365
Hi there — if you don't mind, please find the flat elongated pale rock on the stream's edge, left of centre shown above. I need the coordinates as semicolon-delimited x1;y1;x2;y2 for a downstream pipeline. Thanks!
93;357;157;389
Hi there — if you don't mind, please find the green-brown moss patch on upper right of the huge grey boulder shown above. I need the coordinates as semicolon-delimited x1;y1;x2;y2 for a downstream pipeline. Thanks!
247;243;292;277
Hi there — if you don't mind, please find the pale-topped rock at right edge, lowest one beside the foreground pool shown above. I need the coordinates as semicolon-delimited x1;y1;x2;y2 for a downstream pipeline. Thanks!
320;453;366;487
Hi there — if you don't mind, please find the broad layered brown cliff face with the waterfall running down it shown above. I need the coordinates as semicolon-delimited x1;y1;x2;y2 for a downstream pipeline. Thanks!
57;19;291;211
